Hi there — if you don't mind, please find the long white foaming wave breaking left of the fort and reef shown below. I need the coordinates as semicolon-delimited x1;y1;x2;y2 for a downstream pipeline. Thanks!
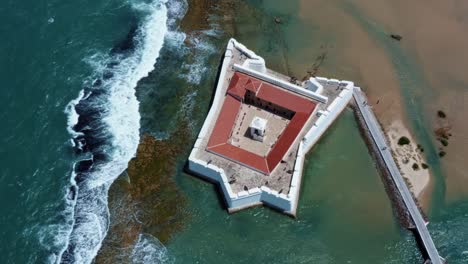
56;0;185;263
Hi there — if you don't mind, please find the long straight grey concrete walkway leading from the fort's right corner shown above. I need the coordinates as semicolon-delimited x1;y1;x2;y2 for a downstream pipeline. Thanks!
353;88;443;264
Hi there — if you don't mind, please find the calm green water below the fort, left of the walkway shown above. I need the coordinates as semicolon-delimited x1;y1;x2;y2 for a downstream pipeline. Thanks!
167;110;421;263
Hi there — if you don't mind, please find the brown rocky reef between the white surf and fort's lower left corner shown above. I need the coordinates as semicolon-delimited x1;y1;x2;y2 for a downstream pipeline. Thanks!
96;126;189;263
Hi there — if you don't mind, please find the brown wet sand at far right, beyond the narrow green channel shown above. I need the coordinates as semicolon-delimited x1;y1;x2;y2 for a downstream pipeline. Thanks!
336;0;468;201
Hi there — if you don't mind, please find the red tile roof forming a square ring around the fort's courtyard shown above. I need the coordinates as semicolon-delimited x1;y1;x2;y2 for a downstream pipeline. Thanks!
207;72;316;174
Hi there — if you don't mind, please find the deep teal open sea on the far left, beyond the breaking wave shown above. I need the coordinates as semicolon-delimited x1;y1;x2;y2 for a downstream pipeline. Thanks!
0;0;165;263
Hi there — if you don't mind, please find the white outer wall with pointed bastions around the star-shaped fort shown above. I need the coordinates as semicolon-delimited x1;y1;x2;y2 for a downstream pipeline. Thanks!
188;39;354;215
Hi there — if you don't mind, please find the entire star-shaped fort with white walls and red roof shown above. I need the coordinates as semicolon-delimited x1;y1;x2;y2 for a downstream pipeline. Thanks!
188;39;354;216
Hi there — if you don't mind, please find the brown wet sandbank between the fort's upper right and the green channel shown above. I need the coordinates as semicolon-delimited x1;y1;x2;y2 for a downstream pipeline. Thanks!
299;0;403;127
